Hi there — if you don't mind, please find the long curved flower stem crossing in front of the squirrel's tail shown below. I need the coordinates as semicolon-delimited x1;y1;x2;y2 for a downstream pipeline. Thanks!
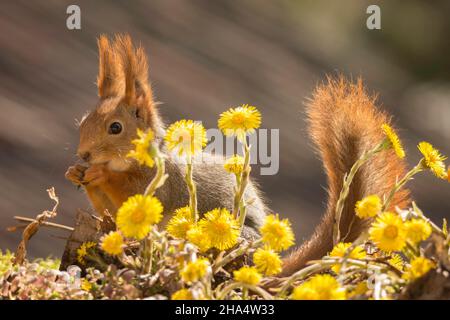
333;140;389;245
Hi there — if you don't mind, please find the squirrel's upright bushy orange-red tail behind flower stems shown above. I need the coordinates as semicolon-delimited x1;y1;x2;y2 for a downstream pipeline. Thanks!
283;76;409;275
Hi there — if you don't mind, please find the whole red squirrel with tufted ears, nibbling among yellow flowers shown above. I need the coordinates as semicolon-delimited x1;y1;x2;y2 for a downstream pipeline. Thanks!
66;35;408;275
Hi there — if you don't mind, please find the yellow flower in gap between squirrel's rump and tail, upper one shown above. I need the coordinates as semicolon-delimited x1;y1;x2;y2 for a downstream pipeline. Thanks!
259;214;294;251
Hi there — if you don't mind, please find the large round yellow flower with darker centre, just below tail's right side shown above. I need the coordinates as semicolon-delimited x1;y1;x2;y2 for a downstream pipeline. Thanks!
369;212;406;252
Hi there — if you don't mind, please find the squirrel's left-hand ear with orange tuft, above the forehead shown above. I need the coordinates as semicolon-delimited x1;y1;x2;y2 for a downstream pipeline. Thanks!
97;35;123;98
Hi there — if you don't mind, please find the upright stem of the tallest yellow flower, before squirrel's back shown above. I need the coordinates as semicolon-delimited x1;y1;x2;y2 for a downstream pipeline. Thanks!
233;140;251;231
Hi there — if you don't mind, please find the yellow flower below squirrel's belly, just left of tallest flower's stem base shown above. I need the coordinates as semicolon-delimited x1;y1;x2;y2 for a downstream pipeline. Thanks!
198;209;239;250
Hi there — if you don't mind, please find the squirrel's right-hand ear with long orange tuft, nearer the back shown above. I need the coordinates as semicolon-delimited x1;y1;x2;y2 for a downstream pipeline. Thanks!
114;34;153;105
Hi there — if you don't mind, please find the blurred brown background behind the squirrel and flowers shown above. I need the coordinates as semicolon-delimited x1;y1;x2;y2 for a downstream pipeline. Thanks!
0;0;450;257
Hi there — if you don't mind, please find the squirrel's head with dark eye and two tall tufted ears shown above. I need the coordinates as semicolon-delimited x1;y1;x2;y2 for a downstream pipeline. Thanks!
77;35;163;171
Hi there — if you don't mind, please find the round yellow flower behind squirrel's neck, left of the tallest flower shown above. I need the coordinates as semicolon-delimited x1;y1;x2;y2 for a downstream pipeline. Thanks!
165;120;208;156
